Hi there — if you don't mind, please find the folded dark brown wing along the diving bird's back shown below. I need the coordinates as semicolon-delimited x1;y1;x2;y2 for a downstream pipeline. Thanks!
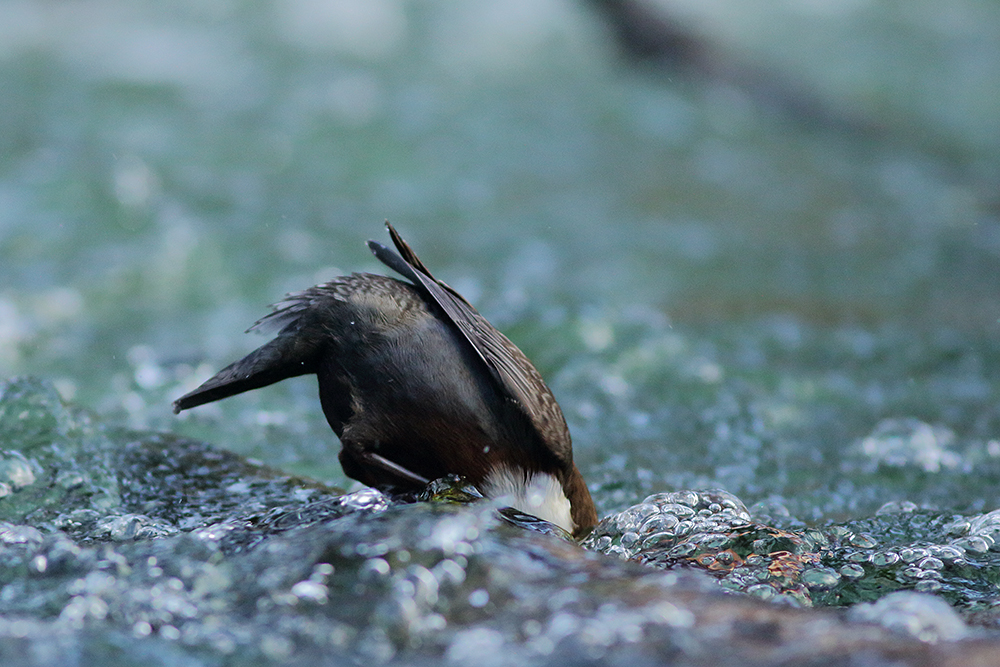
368;222;570;458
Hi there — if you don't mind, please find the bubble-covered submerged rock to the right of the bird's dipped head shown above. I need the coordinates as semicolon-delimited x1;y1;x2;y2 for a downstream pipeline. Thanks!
584;491;1000;627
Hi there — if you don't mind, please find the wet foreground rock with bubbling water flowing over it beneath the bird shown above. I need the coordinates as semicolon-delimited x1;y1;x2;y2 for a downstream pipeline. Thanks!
0;379;1000;665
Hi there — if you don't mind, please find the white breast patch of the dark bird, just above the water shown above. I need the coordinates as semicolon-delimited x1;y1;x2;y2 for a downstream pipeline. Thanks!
480;466;576;533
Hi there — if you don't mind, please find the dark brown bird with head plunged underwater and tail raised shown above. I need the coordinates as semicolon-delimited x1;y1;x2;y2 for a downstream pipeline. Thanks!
173;221;597;538
